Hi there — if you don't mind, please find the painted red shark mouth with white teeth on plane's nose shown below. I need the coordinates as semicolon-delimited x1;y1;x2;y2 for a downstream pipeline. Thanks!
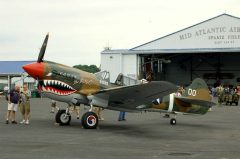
39;80;76;96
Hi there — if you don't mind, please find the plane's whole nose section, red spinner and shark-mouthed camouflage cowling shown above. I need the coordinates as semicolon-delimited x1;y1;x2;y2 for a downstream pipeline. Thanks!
23;61;101;103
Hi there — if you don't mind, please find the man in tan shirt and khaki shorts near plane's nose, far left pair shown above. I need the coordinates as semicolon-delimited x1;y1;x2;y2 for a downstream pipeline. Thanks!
20;84;31;125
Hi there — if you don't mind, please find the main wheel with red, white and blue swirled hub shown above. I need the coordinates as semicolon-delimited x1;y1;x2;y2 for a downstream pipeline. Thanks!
82;112;98;129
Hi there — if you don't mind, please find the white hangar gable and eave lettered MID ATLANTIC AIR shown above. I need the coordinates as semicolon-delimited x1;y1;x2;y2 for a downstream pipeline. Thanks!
102;14;240;54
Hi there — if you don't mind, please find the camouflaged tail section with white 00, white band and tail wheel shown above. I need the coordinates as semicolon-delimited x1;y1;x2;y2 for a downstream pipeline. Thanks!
142;78;215;125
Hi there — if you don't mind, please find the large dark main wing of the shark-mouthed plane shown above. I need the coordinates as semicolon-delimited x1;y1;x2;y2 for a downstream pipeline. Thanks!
90;81;177;111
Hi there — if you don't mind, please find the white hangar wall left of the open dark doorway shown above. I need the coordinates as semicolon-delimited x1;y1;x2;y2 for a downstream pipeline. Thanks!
101;51;138;82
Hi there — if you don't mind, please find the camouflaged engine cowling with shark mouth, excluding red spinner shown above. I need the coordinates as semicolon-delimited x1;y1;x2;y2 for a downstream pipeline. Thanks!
40;62;101;96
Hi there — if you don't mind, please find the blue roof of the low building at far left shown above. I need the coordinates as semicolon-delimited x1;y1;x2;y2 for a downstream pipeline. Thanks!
0;61;35;76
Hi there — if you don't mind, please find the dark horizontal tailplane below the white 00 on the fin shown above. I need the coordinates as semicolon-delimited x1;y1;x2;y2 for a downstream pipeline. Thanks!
175;97;216;107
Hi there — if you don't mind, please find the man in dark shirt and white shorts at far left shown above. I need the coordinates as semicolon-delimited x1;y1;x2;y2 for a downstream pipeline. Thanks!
6;86;20;124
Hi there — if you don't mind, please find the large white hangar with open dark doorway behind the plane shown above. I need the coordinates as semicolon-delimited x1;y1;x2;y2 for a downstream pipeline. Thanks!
101;14;240;85
